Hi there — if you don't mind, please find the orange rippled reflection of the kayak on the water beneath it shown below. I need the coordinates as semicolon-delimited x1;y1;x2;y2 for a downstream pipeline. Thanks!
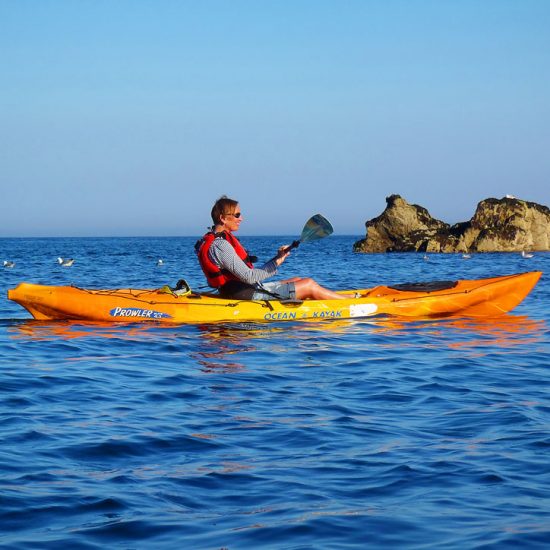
7;314;546;350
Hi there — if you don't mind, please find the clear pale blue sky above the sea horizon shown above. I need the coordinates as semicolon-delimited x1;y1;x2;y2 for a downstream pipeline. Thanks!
0;0;550;236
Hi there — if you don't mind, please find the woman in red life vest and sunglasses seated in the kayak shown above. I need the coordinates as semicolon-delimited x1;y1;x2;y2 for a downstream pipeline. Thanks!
195;196;349;300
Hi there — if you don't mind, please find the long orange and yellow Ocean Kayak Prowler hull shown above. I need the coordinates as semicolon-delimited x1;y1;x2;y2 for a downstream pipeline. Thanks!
8;271;542;324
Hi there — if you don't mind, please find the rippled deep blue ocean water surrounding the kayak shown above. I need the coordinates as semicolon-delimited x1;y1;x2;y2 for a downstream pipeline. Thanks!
0;236;550;550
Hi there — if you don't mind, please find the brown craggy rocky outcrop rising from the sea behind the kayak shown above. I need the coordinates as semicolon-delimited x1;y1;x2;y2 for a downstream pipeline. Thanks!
353;195;550;252
